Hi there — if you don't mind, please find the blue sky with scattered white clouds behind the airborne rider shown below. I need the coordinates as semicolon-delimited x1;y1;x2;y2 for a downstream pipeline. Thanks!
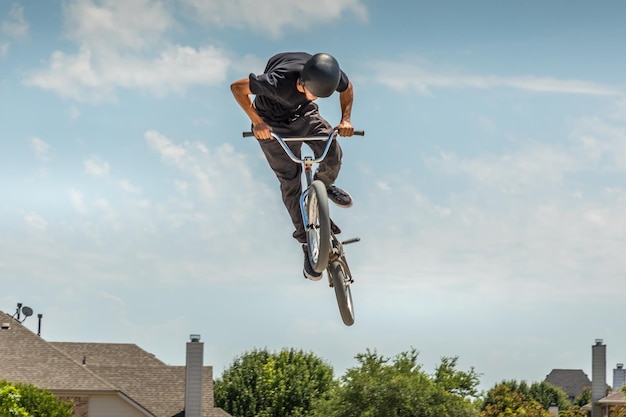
0;0;626;388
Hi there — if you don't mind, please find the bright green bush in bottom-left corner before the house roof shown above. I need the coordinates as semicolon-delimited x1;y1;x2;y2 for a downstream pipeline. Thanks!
0;381;74;417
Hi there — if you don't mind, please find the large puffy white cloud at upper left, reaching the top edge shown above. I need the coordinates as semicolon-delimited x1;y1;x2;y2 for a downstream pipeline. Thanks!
24;0;230;102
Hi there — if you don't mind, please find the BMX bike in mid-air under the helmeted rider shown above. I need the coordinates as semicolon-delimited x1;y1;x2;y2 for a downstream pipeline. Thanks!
243;129;365;326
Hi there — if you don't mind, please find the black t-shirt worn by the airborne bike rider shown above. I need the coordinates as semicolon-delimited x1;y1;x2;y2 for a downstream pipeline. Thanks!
249;52;349;123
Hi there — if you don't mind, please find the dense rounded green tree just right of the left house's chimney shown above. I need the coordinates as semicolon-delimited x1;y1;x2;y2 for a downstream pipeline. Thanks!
214;349;334;417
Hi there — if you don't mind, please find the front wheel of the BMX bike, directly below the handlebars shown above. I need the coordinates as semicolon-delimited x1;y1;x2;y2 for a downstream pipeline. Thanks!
305;180;330;273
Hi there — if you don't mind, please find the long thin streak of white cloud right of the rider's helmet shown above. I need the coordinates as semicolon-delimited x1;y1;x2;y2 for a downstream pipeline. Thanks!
369;59;624;95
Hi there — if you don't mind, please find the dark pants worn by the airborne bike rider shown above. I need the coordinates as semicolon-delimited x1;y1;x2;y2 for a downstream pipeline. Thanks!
259;103;342;243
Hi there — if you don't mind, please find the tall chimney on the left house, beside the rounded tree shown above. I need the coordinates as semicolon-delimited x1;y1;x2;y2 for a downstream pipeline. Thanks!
185;334;204;417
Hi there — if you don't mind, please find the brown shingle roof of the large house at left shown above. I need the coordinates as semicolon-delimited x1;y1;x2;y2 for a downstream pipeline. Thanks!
0;311;231;417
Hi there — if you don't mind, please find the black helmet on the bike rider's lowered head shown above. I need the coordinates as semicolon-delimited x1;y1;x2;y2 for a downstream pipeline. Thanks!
300;54;341;97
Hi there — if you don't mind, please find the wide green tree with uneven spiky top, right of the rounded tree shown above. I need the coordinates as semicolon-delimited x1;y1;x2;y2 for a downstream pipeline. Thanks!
311;349;479;417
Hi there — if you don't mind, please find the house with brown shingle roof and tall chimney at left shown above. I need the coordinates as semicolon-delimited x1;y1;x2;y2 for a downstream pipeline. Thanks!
0;311;230;417
